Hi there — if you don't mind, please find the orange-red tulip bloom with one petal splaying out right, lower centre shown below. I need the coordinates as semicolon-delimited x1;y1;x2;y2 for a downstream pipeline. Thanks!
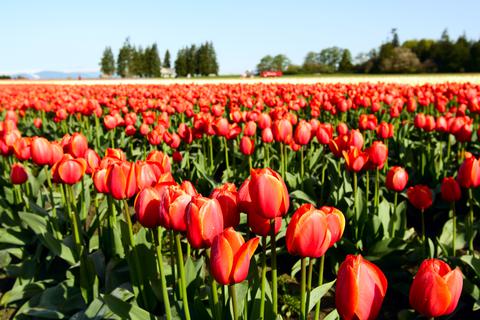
210;228;259;285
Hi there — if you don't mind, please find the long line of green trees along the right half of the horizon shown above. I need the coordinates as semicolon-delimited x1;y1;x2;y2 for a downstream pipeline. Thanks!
257;29;480;74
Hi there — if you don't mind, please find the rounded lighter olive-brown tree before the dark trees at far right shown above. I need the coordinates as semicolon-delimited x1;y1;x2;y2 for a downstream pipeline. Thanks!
380;47;421;73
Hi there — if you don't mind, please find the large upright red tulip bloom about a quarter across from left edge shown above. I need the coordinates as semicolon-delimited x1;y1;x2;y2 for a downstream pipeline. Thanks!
106;161;137;200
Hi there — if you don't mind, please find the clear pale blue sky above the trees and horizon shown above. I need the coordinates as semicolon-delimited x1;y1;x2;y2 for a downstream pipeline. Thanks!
0;0;480;73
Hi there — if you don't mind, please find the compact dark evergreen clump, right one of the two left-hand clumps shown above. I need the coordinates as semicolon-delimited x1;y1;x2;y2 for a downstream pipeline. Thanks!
175;42;218;77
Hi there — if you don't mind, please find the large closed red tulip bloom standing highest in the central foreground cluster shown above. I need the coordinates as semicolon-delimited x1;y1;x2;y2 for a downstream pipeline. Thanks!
249;168;290;219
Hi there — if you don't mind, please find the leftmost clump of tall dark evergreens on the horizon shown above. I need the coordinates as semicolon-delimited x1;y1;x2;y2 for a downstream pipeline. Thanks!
100;38;171;78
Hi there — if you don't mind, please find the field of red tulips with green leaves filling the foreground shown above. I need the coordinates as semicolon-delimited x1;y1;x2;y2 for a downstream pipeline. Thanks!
0;83;480;320
